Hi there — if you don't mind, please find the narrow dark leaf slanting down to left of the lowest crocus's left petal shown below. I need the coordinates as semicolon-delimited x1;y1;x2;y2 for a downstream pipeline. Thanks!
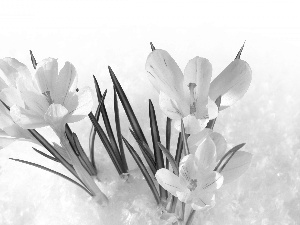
122;137;160;204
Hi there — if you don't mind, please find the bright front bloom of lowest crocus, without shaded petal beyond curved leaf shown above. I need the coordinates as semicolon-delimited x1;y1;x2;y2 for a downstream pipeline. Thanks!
155;138;223;210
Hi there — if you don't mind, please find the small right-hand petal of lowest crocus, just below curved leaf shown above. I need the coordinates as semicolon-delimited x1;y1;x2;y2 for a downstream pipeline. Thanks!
199;171;224;192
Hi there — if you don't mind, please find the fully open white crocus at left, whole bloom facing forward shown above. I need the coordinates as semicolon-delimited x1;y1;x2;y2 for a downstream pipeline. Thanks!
4;58;93;133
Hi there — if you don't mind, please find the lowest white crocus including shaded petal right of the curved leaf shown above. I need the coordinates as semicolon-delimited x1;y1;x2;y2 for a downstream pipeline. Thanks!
155;133;251;210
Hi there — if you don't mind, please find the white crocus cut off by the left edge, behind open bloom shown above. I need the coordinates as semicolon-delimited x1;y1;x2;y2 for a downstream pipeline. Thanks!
0;58;32;149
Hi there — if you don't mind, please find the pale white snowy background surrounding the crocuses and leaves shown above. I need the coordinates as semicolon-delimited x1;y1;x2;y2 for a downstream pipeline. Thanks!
0;0;300;225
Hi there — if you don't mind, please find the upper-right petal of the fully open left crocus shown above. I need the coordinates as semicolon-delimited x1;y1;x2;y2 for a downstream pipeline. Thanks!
51;62;77;105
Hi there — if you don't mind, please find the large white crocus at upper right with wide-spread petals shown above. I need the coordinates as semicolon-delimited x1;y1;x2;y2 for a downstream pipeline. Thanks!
146;49;251;134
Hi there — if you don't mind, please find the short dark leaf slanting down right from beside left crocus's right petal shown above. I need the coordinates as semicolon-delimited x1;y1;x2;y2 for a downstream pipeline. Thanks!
89;112;123;175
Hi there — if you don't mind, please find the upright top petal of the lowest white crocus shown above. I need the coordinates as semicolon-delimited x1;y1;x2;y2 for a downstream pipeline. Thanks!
195;136;217;171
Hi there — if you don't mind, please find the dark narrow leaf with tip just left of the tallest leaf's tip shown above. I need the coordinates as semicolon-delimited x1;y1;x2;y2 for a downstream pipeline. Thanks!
93;76;122;165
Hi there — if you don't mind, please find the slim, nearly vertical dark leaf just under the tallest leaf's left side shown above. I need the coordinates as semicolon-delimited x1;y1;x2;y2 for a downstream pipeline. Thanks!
114;87;128;172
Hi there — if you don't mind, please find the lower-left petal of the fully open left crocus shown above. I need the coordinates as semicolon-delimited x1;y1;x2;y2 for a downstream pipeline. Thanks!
10;105;47;129
